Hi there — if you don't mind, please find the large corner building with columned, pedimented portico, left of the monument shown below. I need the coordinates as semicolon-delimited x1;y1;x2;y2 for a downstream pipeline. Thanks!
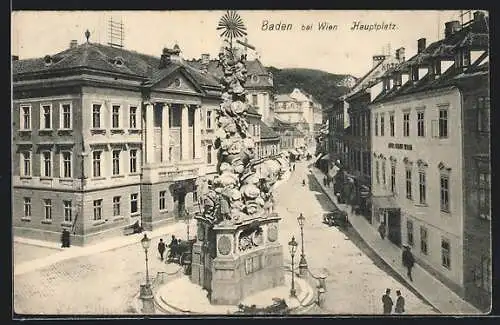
12;41;221;245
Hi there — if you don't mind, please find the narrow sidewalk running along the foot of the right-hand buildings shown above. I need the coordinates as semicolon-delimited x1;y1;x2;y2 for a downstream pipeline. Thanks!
310;167;481;315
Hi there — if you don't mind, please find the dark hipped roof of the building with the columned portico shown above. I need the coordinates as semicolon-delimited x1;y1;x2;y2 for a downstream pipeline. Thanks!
12;42;220;87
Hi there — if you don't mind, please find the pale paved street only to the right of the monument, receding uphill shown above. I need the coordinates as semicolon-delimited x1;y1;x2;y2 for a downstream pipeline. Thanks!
276;162;436;314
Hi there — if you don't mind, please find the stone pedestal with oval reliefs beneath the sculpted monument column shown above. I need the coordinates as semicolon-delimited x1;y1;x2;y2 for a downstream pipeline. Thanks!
191;214;284;305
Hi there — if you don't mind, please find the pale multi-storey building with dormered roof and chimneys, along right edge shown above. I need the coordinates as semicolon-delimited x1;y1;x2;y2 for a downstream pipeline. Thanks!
369;12;491;310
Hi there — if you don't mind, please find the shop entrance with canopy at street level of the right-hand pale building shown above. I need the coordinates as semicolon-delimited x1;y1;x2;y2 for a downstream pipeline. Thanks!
371;196;401;247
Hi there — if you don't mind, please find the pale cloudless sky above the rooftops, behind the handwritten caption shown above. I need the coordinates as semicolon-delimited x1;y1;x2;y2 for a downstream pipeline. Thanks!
11;10;469;77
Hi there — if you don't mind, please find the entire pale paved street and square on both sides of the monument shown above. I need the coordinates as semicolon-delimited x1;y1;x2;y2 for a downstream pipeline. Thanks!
14;162;434;314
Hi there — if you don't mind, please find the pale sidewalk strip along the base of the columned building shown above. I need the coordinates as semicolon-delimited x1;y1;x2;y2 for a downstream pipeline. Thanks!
13;219;196;276
